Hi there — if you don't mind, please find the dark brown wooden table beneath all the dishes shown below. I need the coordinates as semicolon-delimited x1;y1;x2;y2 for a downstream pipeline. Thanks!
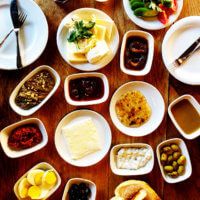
0;0;200;200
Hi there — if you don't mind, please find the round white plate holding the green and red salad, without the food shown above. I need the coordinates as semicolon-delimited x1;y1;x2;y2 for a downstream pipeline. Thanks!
123;0;183;30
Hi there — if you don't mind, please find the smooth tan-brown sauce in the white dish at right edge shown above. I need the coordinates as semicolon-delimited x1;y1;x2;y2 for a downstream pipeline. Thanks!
171;99;200;134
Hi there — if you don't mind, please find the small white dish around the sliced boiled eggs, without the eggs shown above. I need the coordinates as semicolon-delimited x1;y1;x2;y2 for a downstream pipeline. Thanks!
13;162;61;200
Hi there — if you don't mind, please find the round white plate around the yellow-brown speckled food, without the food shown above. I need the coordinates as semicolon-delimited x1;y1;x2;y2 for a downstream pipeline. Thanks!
110;81;165;137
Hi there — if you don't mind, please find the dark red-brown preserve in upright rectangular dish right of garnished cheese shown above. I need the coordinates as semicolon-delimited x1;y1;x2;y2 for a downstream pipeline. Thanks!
124;36;148;70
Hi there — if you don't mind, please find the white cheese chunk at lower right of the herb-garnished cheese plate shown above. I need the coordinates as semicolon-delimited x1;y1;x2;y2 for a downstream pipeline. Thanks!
86;40;109;64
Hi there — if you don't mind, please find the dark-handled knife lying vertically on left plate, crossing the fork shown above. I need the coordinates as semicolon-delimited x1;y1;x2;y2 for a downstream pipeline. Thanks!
10;0;22;68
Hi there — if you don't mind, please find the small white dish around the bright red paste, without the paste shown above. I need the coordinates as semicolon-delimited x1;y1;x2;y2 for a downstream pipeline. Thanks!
0;118;48;158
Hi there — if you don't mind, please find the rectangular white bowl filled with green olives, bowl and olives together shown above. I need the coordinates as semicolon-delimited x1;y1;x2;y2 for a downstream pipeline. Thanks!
156;138;192;183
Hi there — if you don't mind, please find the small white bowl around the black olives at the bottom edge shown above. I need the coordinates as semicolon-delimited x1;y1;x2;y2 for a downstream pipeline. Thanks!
62;178;97;200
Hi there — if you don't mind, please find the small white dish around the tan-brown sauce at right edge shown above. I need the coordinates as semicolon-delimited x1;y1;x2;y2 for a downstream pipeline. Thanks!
168;94;200;140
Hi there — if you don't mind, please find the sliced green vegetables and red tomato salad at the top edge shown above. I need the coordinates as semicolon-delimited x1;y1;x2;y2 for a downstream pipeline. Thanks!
129;0;178;24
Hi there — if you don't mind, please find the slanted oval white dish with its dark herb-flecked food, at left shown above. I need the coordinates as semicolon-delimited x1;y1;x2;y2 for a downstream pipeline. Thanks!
9;65;60;116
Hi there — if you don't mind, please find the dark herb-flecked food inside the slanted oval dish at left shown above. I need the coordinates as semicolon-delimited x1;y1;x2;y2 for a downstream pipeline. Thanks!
15;70;55;110
